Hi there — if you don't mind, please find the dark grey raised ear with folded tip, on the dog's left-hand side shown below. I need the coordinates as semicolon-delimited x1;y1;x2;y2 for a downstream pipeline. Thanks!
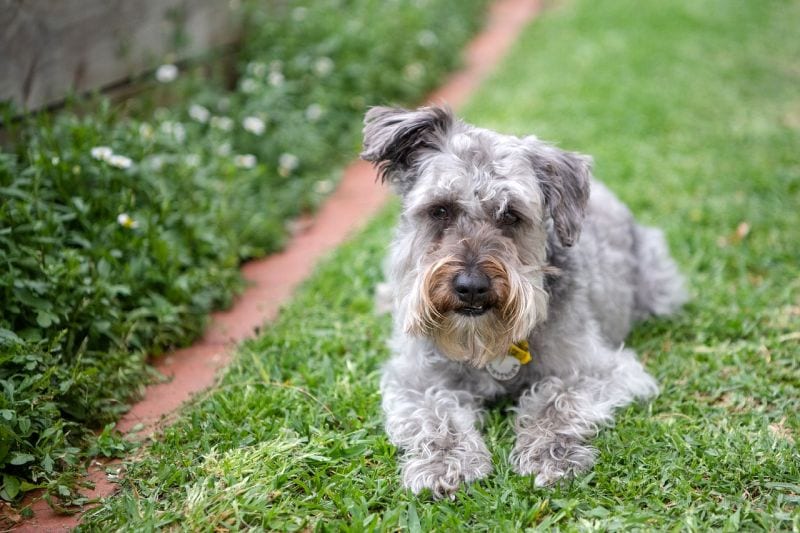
361;106;455;194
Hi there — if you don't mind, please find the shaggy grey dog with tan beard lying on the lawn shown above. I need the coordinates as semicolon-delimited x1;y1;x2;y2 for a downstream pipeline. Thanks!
361;106;687;499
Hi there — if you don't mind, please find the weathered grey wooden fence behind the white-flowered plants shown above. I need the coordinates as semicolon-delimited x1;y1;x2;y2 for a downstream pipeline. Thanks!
0;0;244;109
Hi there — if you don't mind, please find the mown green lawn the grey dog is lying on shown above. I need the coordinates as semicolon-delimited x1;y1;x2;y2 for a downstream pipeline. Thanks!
78;0;800;531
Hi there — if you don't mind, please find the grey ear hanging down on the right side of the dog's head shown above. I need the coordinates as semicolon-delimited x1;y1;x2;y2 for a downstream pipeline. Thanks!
526;137;592;246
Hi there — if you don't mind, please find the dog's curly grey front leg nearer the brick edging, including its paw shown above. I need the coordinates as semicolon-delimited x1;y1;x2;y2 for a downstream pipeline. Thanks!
381;368;492;499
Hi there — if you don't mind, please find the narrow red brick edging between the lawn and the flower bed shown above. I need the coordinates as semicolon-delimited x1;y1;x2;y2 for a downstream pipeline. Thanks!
16;0;539;531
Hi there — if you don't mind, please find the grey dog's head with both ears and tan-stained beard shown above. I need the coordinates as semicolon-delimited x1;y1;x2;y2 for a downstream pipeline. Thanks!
361;107;591;368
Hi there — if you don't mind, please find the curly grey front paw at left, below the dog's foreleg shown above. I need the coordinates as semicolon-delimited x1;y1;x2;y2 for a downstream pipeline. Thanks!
403;446;492;500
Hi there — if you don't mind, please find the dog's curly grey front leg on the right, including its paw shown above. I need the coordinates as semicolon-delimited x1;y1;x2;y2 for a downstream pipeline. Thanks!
511;349;658;487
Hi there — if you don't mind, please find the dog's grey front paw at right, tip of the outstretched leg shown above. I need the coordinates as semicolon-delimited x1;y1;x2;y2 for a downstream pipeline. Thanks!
511;437;597;487
